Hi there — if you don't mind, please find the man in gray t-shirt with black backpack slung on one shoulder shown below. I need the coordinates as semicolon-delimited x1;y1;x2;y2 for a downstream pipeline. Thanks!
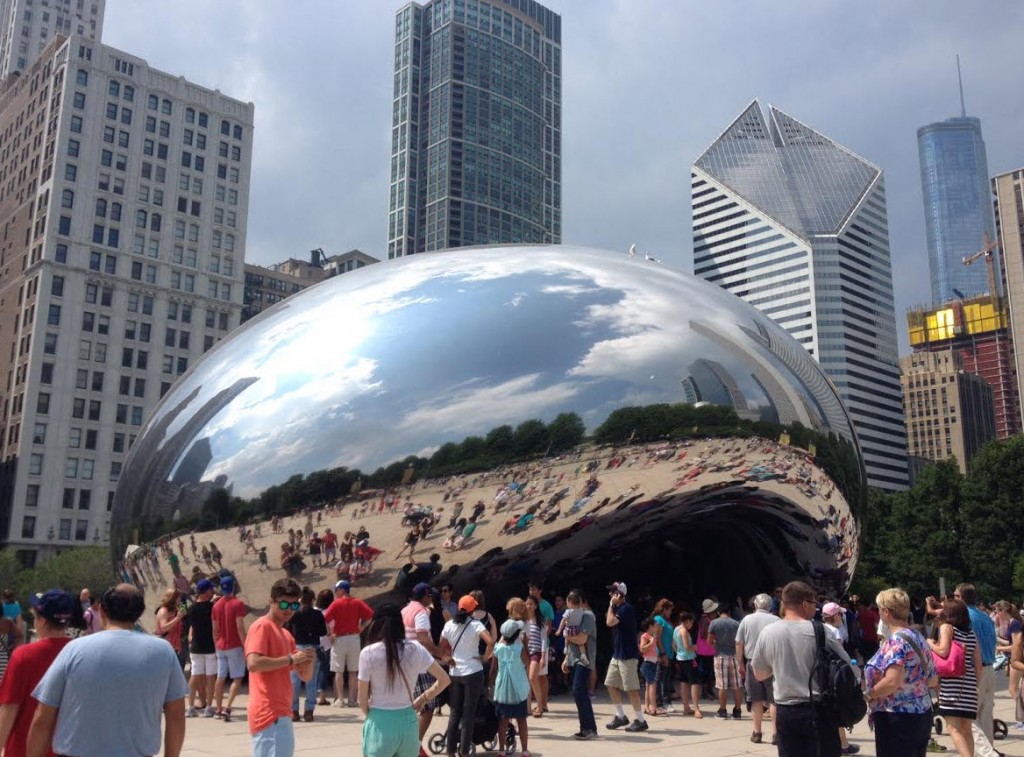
751;581;850;757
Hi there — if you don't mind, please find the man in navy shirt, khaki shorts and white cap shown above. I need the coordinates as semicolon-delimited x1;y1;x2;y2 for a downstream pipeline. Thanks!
604;582;647;733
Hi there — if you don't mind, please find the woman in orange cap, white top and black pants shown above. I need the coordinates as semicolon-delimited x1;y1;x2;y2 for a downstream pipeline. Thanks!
440;594;495;757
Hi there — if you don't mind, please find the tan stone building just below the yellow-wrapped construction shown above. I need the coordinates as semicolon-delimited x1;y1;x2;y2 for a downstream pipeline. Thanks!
900;347;995;473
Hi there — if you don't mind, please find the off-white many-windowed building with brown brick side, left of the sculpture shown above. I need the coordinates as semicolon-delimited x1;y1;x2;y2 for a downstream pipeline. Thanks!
0;35;253;563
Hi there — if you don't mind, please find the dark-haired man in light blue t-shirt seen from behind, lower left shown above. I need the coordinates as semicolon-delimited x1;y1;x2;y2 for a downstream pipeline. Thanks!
28;584;188;757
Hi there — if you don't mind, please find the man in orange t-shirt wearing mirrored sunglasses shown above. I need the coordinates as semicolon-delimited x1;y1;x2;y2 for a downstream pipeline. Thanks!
245;579;314;757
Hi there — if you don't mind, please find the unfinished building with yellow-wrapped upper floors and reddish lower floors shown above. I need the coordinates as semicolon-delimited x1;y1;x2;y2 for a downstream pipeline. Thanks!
906;294;1021;439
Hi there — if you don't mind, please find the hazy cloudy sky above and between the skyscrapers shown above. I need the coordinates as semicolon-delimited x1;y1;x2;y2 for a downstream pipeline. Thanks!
103;0;1024;351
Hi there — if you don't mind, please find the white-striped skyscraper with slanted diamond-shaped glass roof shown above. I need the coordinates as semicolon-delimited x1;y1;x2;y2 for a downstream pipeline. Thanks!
691;100;908;490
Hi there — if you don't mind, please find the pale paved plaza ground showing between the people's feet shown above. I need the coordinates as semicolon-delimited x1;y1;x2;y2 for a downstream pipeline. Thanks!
182;677;1024;757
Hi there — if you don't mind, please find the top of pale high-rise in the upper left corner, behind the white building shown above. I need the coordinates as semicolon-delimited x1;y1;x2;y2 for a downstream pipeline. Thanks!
0;0;106;80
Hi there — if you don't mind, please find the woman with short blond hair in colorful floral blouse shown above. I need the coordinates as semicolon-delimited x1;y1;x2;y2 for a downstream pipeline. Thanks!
864;589;938;757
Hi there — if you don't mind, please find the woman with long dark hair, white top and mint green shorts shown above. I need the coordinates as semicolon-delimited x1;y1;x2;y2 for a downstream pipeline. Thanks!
358;603;449;757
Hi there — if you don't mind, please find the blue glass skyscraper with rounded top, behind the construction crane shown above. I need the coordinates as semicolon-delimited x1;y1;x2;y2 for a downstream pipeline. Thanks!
918;116;995;305
